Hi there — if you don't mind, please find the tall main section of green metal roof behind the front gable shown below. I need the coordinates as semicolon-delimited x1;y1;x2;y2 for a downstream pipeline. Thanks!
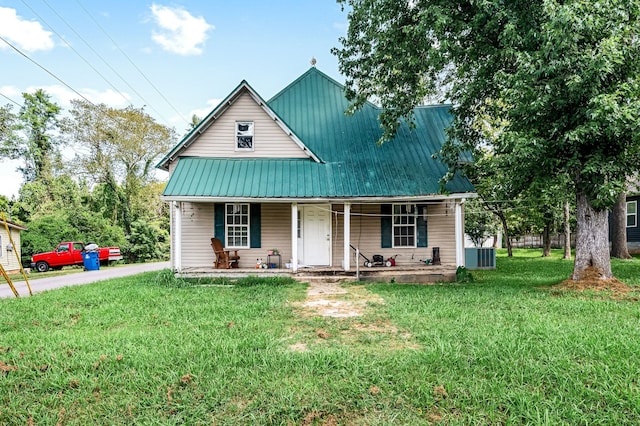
269;68;473;195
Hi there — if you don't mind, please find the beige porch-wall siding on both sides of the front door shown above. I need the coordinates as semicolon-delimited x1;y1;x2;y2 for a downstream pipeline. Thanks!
176;202;456;268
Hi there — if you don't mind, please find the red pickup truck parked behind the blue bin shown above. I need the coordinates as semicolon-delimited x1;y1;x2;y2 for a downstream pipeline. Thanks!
31;241;122;272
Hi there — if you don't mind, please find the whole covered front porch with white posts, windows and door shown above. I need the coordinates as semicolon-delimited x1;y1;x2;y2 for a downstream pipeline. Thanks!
171;195;464;276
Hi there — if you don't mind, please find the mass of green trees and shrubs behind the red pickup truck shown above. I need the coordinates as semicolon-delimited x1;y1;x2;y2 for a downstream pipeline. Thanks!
0;90;175;261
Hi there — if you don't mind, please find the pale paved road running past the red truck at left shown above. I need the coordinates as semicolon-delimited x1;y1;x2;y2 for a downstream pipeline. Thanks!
0;262;169;298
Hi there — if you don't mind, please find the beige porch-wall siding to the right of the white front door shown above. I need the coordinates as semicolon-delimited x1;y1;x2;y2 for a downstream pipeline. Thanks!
332;202;456;267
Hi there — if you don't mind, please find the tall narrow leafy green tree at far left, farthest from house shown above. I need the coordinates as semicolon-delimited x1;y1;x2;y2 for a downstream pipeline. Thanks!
0;89;60;182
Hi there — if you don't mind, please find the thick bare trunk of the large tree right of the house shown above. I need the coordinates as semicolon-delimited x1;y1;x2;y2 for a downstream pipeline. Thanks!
571;185;613;280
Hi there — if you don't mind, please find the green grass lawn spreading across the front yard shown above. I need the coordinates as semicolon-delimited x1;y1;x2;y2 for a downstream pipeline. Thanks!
0;250;640;425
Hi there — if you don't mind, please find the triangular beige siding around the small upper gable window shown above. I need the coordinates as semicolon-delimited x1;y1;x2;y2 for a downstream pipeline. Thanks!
180;93;307;158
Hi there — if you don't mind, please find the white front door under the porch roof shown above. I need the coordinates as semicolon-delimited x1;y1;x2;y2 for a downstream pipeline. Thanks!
298;204;331;266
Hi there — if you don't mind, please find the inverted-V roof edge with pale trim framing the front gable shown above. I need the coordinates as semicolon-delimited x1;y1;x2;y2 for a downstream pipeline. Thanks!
156;80;320;171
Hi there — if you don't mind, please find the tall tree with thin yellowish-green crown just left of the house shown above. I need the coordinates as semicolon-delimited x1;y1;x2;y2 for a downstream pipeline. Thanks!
64;100;175;235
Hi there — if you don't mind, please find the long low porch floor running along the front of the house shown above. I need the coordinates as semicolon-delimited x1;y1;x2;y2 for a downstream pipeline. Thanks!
176;264;456;283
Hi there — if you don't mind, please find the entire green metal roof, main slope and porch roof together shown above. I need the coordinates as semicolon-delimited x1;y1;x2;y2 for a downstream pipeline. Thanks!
164;68;473;198
